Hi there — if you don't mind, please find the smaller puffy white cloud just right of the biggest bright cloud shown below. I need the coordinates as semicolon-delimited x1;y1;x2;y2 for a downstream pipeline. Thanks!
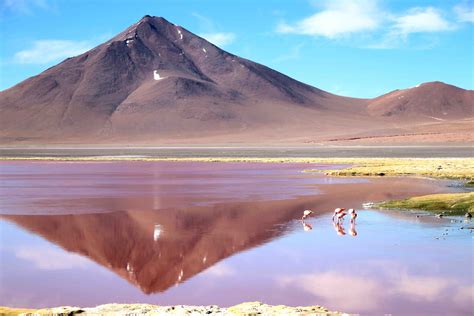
393;7;453;36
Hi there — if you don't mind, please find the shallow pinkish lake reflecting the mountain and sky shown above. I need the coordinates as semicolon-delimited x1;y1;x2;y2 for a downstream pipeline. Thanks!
0;161;474;315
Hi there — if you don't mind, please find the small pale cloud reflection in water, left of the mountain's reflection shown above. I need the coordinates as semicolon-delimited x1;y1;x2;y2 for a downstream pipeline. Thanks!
15;247;90;270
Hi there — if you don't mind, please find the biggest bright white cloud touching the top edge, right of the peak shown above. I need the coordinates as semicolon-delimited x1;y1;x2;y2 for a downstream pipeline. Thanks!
277;0;384;38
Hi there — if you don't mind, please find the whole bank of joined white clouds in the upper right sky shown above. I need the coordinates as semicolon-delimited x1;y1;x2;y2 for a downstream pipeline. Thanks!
276;0;464;48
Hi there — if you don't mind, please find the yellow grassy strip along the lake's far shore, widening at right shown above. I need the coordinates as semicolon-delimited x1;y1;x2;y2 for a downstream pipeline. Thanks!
0;155;474;181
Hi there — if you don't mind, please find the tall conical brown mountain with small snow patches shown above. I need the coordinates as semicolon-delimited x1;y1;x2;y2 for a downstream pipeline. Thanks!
0;16;360;142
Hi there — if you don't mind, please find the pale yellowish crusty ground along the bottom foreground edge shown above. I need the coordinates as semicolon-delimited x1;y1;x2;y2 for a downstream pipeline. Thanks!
0;302;347;316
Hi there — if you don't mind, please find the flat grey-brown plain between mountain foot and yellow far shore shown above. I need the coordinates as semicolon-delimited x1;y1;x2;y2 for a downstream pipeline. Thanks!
0;144;473;158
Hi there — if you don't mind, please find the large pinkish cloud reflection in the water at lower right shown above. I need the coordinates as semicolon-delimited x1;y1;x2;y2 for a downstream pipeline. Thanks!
279;260;474;315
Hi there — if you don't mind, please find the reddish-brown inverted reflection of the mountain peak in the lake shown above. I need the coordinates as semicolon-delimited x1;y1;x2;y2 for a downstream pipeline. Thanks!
2;201;310;294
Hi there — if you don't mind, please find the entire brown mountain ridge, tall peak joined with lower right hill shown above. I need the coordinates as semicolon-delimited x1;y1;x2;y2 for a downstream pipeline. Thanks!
0;16;474;143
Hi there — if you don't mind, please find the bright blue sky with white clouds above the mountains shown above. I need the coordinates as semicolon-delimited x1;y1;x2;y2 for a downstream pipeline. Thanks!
0;0;474;98
